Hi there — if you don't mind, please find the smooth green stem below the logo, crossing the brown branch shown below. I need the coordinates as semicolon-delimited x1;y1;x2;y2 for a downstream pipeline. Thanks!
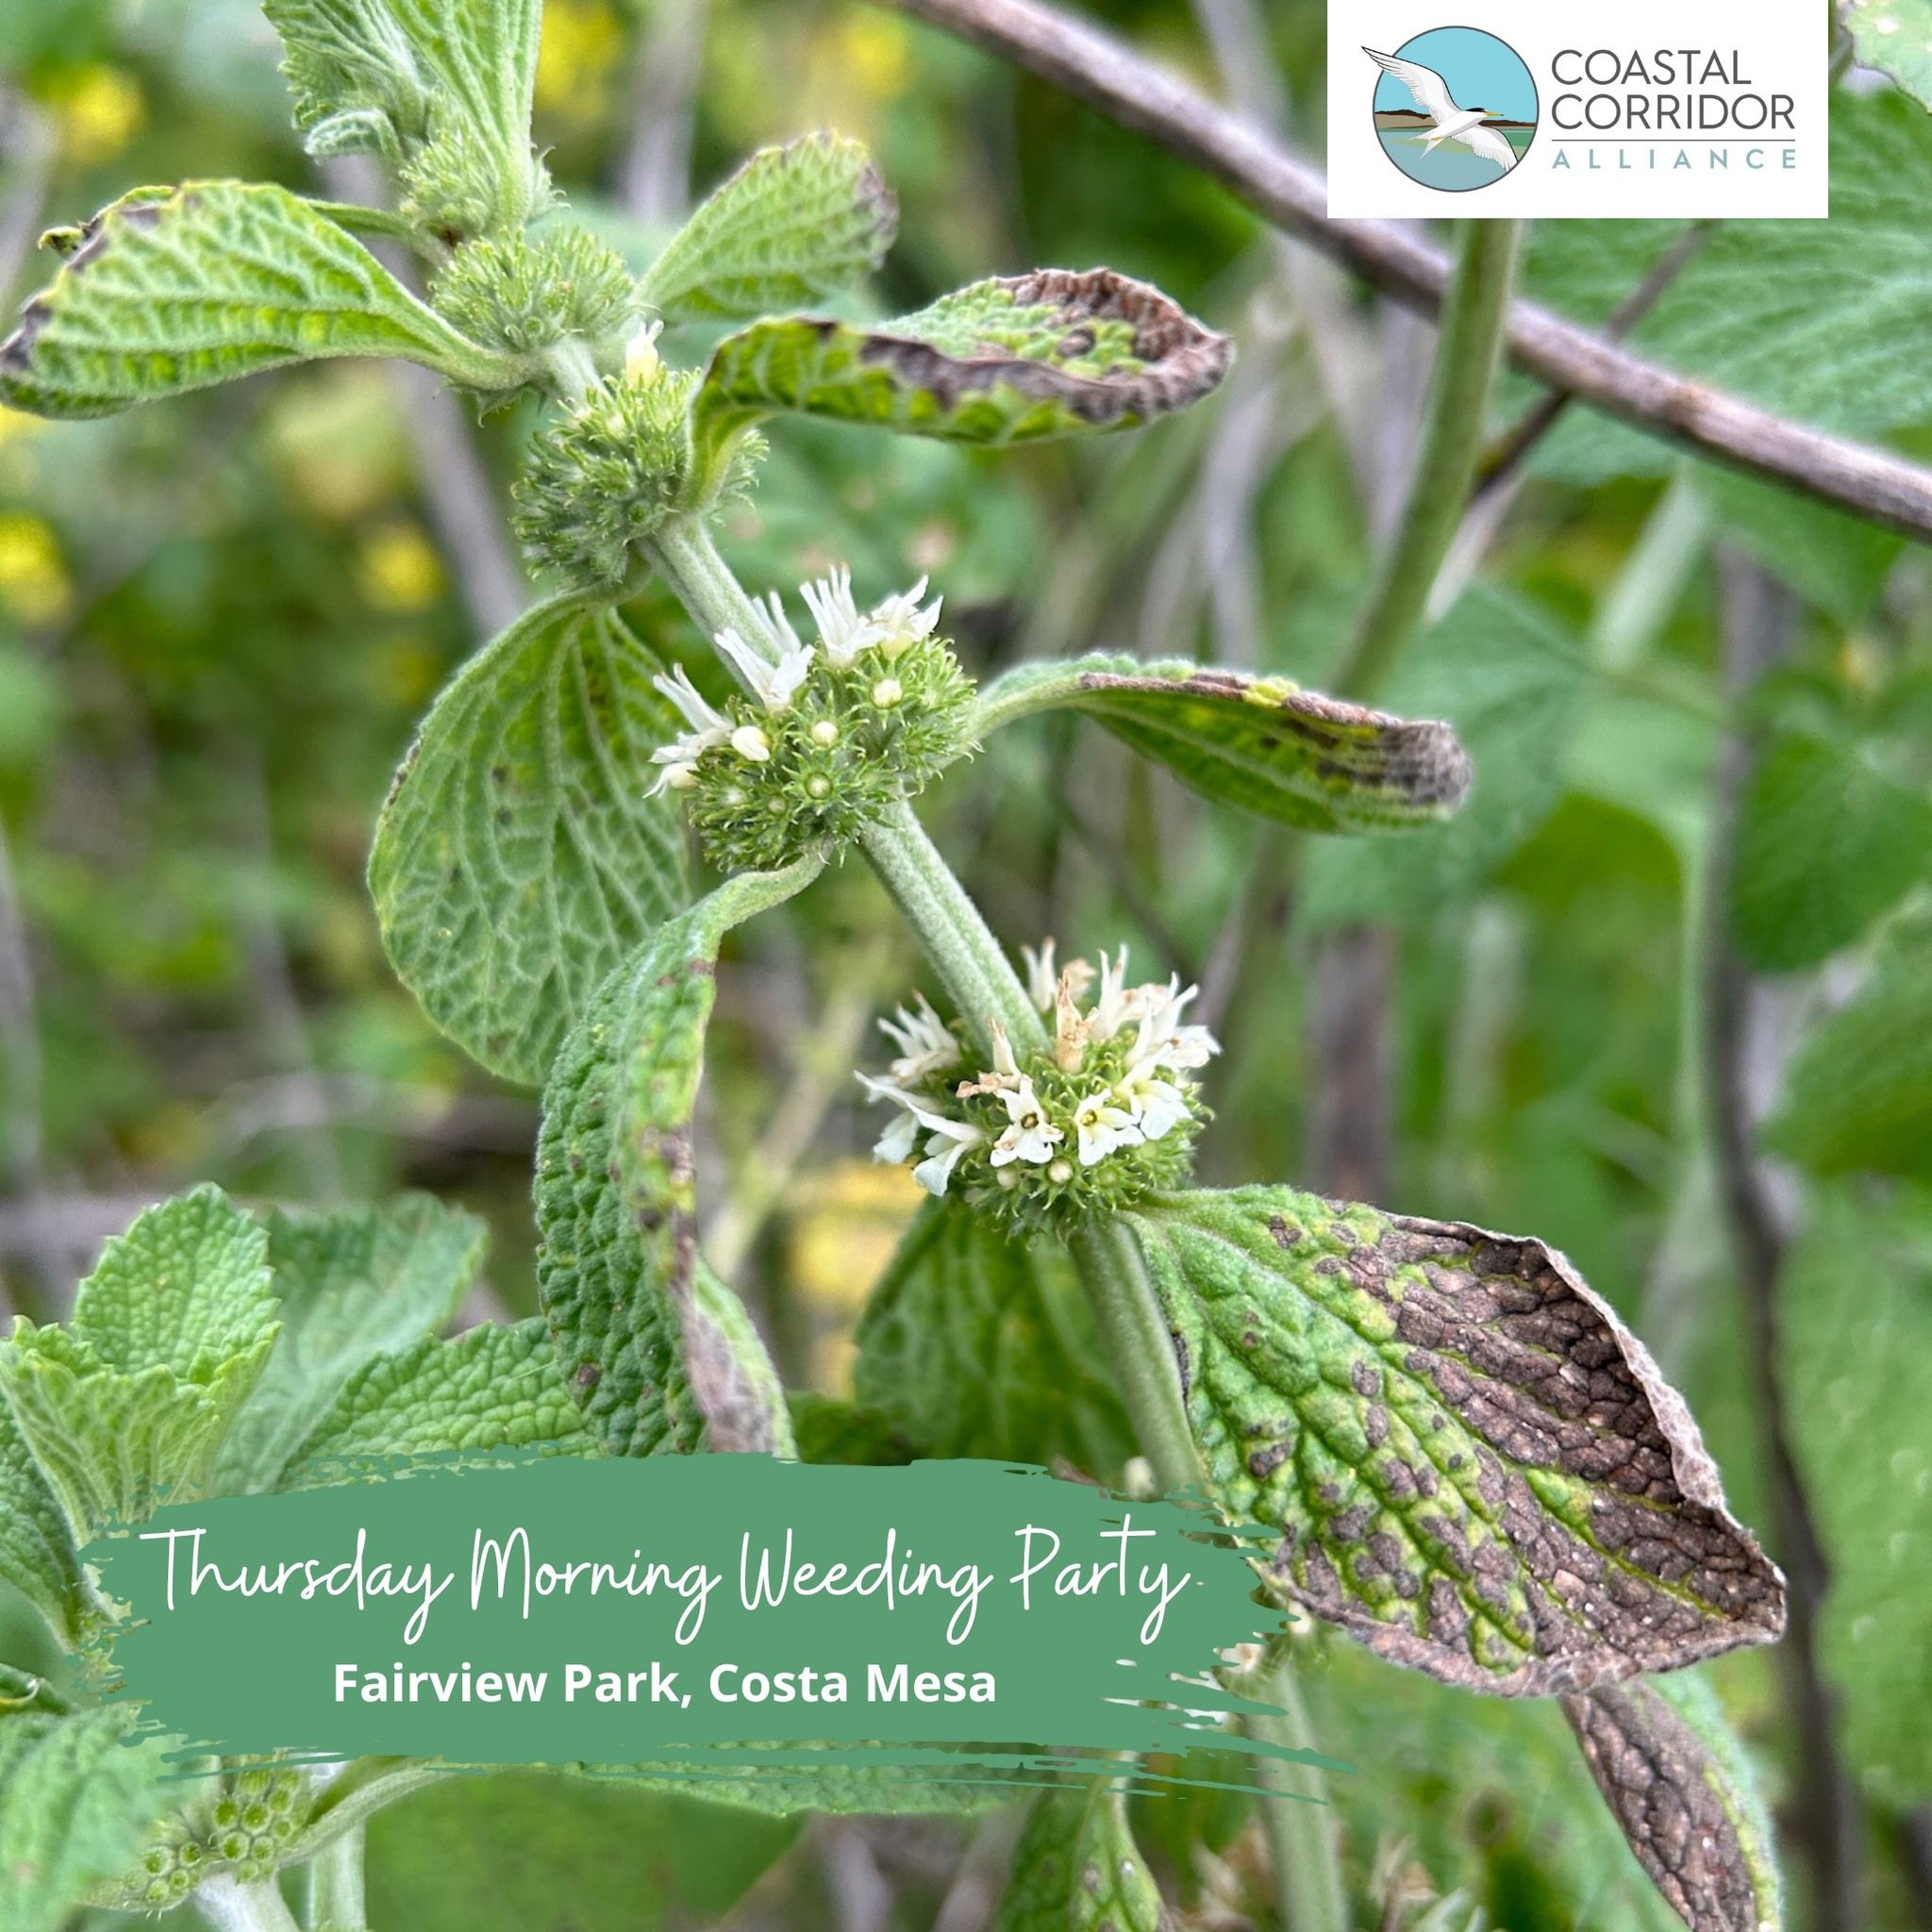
1331;220;1523;697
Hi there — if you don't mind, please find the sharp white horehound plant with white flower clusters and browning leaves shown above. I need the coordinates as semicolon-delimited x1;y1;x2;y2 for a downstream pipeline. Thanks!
0;0;1783;1932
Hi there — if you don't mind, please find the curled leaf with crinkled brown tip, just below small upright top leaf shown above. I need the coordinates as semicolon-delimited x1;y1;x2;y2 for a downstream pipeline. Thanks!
691;269;1231;475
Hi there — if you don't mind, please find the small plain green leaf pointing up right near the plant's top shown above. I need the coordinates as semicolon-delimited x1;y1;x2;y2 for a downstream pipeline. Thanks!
640;133;898;323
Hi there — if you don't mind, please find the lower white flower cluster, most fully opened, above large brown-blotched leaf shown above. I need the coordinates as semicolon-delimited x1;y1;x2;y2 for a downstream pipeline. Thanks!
858;939;1221;1226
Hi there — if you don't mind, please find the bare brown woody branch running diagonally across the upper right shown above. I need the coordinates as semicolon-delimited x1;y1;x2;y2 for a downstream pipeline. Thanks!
885;0;1932;542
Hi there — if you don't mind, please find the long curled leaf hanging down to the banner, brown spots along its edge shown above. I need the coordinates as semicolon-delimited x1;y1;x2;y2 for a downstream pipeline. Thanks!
537;858;824;1455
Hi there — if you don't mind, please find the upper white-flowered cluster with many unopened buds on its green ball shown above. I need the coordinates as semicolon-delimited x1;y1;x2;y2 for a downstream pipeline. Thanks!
653;570;972;872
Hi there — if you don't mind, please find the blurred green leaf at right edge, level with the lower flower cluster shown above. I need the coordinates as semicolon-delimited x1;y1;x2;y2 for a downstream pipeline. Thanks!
1762;916;1932;1180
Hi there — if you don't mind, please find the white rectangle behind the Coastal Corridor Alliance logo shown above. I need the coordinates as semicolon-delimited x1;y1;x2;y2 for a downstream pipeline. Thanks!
1327;0;1829;218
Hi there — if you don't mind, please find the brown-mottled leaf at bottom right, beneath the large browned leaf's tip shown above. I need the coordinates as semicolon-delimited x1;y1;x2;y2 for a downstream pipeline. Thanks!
1563;1677;1783;1932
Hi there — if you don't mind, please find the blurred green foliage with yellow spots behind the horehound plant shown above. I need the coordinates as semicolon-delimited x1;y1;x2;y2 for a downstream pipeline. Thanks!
0;0;1932;1932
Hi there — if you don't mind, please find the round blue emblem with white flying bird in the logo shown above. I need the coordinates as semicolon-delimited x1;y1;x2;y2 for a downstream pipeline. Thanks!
1362;27;1536;195
